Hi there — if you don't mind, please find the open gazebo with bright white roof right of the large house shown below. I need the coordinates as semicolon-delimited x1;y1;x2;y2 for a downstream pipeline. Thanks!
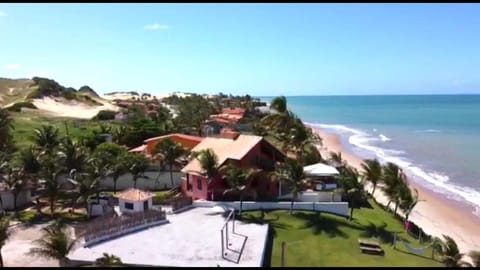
303;163;340;190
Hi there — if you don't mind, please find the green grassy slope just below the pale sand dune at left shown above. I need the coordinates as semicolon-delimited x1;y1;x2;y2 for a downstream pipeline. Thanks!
11;111;118;151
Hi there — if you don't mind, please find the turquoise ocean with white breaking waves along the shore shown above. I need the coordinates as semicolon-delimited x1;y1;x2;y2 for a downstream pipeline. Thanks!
261;95;480;216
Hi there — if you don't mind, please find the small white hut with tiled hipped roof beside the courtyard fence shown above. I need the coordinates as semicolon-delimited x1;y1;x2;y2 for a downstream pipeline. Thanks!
114;188;153;214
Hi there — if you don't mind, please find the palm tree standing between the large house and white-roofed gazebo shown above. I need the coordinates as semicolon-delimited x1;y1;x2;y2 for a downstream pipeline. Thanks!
276;158;305;214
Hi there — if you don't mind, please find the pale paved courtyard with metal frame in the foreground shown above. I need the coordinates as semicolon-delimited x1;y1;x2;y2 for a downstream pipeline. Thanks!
68;207;268;267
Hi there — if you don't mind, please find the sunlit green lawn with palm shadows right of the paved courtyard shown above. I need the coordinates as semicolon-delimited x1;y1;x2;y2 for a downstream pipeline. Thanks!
242;200;442;267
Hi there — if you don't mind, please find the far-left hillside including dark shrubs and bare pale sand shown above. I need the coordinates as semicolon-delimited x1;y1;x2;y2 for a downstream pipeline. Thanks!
0;77;118;119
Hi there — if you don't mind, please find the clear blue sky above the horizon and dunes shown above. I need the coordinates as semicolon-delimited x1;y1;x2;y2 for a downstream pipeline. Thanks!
0;4;480;96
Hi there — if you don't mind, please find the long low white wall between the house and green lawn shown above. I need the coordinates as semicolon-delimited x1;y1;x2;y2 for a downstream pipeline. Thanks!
193;200;349;216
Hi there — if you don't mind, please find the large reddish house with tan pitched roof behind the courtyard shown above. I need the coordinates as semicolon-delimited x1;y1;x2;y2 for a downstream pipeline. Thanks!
181;134;285;200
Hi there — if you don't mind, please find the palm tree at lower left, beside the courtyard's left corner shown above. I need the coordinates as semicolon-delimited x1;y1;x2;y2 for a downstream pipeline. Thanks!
29;221;76;266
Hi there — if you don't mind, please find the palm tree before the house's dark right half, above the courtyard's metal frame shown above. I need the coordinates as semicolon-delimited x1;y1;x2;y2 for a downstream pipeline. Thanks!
220;163;254;214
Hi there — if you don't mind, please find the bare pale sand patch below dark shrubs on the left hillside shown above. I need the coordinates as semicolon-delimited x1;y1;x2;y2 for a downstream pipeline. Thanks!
33;97;119;119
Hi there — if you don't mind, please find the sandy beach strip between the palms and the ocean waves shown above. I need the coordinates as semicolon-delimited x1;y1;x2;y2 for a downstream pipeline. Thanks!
306;125;480;255
